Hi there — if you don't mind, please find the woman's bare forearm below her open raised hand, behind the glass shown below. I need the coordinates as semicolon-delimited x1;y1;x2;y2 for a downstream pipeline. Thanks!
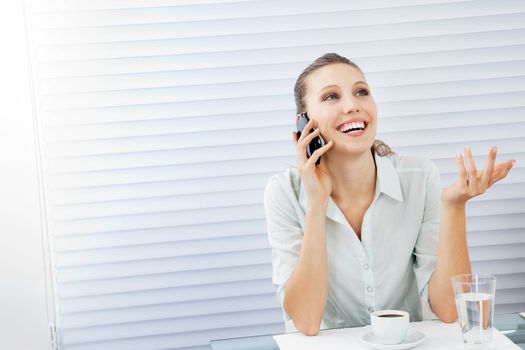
428;201;471;322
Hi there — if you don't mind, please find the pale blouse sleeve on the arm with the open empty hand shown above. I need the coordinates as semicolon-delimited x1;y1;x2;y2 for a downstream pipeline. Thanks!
414;162;441;318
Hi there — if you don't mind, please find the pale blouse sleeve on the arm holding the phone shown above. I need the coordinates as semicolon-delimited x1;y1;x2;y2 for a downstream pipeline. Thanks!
264;176;303;321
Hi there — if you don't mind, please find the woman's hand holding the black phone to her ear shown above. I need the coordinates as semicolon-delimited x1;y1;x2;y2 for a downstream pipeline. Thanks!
294;119;334;205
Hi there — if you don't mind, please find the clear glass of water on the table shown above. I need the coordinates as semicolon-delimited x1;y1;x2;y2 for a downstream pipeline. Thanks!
452;274;496;350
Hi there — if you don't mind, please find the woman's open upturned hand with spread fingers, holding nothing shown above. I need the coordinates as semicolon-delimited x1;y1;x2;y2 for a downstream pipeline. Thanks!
441;146;516;204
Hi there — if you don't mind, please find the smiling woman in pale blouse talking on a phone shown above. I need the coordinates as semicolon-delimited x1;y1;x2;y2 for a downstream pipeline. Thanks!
265;54;514;335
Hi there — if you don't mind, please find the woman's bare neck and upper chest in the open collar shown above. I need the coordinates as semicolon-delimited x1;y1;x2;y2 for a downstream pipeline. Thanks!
326;152;376;205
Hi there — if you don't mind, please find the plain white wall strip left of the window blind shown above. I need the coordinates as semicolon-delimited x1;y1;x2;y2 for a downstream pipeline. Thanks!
0;1;50;350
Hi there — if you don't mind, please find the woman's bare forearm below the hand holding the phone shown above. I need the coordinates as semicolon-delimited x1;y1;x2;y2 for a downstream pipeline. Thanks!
284;205;328;335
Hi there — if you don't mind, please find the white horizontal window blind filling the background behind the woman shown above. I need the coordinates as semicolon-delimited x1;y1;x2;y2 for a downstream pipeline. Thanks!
26;0;525;350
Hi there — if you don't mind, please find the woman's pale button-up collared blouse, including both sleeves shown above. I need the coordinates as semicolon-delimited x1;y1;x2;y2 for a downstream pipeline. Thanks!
264;155;441;328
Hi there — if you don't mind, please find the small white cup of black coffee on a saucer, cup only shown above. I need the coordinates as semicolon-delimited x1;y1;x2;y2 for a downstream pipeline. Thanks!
370;310;410;345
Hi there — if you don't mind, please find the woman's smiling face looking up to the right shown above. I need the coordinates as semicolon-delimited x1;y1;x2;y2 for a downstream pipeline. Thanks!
304;63;377;153
